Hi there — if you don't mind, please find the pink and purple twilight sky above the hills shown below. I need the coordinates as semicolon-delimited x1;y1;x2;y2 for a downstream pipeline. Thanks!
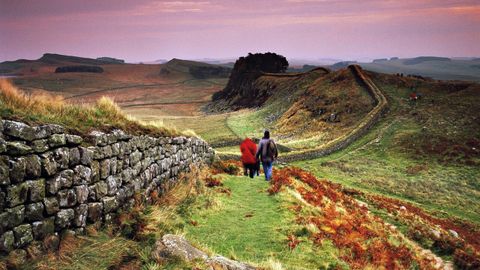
0;0;480;62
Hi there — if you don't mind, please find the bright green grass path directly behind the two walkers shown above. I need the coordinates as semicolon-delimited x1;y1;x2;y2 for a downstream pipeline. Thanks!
185;176;339;269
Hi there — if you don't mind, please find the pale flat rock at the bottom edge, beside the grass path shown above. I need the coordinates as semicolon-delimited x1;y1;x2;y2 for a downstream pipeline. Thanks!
152;234;256;270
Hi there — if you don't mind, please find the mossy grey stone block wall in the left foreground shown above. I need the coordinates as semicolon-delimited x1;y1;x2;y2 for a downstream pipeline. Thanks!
0;120;214;253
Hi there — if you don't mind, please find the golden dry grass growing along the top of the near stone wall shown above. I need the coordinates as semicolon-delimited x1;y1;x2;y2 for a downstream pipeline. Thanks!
0;79;180;136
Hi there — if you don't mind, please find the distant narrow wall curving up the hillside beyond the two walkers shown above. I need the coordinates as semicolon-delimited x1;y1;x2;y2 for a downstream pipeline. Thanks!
217;65;389;162
